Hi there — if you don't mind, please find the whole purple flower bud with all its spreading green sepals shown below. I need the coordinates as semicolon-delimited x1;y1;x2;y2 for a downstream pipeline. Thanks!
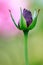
9;8;40;31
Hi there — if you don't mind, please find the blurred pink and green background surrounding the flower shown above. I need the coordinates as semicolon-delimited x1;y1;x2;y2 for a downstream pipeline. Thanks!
0;0;43;65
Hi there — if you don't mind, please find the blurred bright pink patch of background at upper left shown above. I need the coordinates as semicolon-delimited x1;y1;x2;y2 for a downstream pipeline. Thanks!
0;0;26;35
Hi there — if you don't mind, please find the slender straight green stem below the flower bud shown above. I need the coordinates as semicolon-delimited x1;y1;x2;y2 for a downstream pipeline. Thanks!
24;31;28;65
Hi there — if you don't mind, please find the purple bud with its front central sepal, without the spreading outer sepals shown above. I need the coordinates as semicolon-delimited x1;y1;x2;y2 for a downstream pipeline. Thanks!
18;9;32;30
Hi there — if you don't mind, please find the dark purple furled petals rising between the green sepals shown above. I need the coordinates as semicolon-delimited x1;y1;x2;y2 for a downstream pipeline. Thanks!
23;9;32;27
